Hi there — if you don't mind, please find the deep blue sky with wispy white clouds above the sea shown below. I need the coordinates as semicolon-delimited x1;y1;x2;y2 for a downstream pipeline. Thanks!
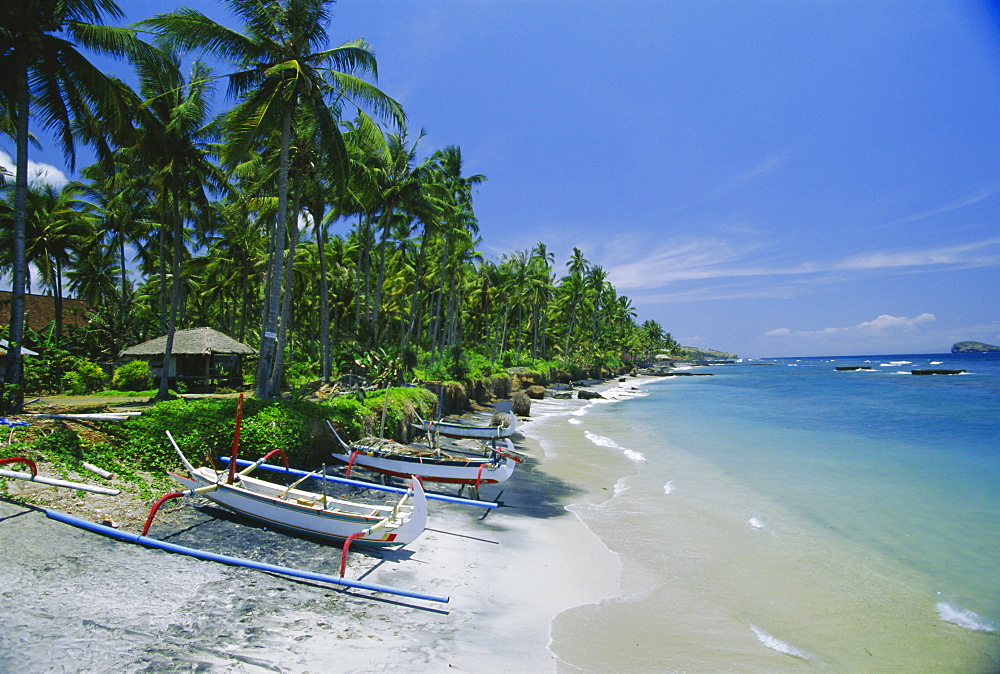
7;0;1000;357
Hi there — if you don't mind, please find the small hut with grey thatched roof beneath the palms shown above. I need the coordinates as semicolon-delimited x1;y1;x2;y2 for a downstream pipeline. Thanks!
118;328;257;389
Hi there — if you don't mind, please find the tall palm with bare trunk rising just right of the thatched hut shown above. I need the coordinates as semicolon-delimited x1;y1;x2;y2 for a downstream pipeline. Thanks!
142;0;403;398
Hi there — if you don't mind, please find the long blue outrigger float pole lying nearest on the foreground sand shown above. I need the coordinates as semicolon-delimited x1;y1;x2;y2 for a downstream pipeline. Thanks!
43;508;449;604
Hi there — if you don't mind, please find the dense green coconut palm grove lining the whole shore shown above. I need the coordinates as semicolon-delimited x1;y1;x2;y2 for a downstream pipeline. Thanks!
0;0;677;410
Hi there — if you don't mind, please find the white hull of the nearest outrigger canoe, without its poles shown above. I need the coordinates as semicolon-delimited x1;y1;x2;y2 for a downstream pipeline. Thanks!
171;468;427;546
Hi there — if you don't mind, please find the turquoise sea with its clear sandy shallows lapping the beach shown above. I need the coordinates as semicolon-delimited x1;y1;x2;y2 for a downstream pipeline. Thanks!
528;354;1000;672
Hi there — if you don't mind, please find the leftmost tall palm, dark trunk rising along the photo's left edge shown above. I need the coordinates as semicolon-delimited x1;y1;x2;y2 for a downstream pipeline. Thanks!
0;0;145;410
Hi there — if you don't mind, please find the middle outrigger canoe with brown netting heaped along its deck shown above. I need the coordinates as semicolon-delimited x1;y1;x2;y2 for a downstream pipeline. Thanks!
328;424;520;492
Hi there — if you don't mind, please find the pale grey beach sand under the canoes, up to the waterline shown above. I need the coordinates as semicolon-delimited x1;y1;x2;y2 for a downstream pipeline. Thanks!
0;410;619;672
